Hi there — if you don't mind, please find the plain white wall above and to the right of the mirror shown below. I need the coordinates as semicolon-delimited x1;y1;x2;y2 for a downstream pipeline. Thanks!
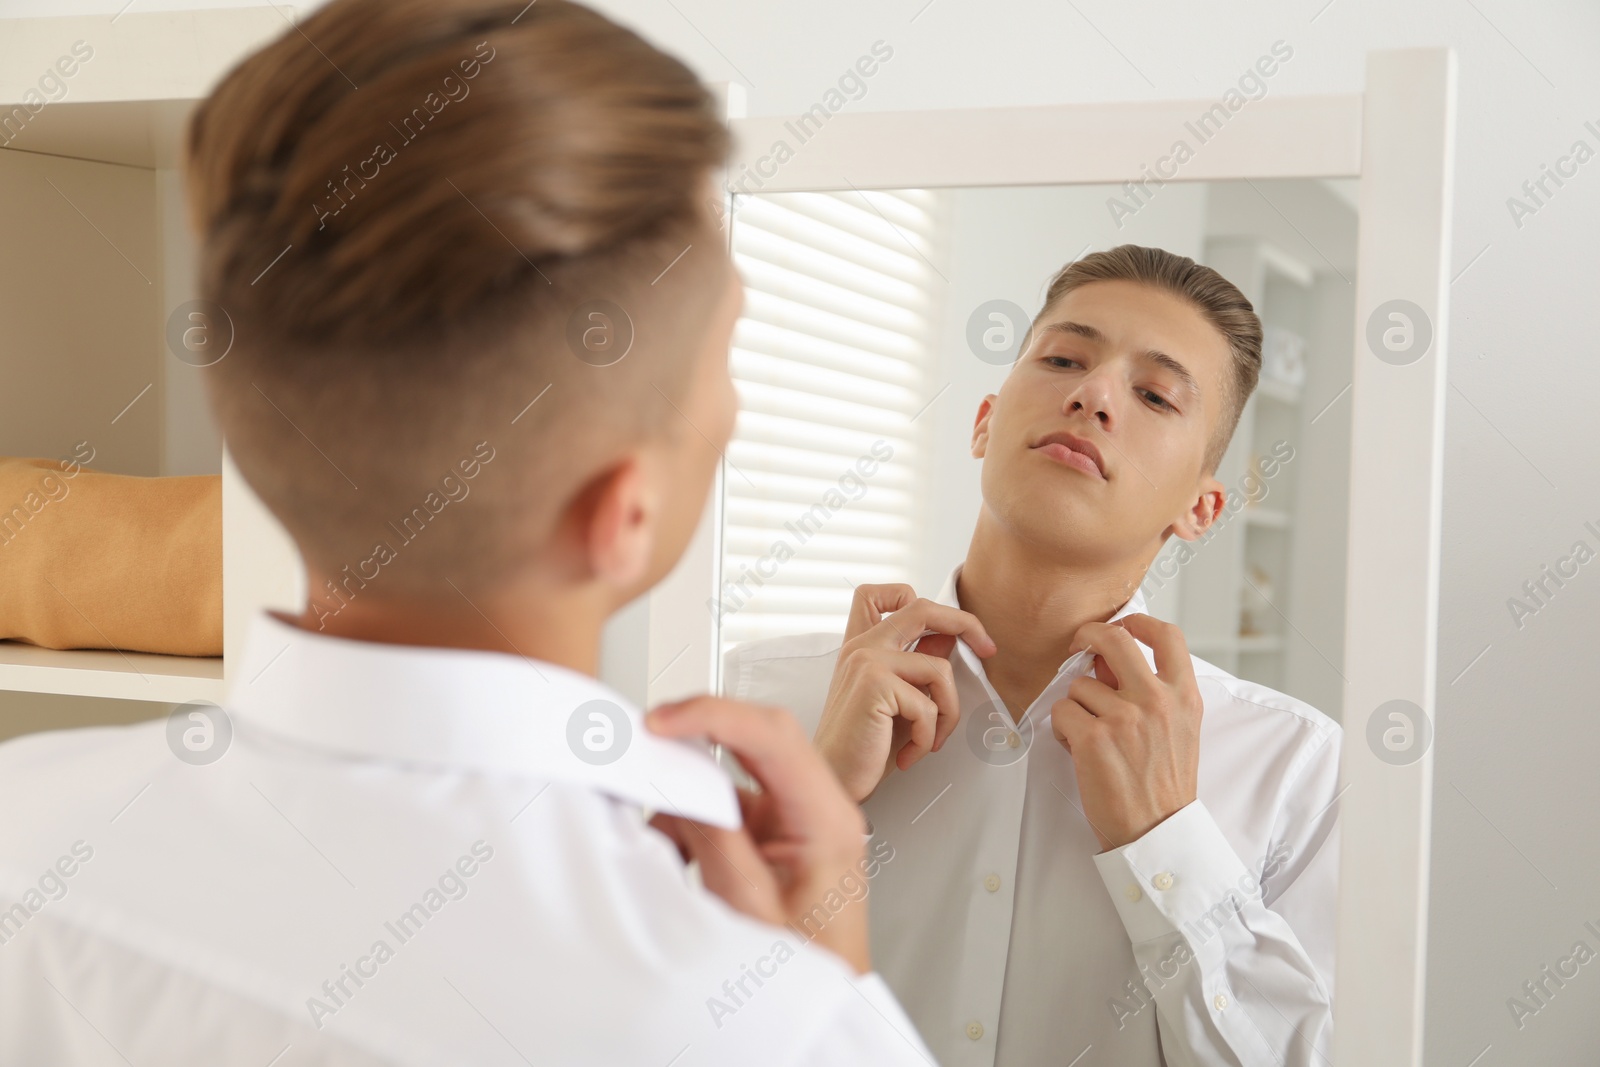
15;0;1600;1067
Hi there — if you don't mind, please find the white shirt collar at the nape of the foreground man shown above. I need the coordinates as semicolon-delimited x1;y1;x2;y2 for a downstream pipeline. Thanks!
226;611;741;829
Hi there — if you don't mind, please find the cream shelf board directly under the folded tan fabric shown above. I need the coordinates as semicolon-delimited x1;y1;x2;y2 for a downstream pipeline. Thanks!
0;641;222;704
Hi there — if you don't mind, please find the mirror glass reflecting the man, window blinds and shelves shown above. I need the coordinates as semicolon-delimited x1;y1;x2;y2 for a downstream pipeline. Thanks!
710;179;1357;1067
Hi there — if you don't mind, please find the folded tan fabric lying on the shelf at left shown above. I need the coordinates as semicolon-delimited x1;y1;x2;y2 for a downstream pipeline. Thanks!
0;458;222;656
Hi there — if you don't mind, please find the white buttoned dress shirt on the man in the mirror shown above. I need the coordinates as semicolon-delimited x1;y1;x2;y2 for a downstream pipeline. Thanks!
725;568;1339;1067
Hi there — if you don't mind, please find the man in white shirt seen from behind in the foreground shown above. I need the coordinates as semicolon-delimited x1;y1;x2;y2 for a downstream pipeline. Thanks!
0;0;926;1067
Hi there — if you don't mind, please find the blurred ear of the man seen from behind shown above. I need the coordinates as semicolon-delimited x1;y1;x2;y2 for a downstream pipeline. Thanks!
568;454;661;589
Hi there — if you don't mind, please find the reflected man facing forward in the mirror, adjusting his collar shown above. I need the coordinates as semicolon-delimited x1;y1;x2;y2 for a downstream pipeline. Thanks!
725;246;1339;1067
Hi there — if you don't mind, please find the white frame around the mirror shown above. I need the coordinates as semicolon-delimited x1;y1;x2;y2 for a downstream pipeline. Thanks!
648;48;1456;1067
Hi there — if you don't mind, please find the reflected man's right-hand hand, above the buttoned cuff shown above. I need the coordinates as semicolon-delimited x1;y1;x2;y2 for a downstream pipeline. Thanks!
1050;614;1203;851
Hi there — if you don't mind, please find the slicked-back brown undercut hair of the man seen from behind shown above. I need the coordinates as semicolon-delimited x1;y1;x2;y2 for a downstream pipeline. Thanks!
186;0;733;595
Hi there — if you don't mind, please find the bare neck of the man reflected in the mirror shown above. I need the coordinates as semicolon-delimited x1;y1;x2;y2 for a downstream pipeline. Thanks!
957;512;1149;720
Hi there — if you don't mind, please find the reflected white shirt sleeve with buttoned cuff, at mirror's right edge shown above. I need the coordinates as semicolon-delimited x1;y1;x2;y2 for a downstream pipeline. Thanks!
1094;728;1339;1067
